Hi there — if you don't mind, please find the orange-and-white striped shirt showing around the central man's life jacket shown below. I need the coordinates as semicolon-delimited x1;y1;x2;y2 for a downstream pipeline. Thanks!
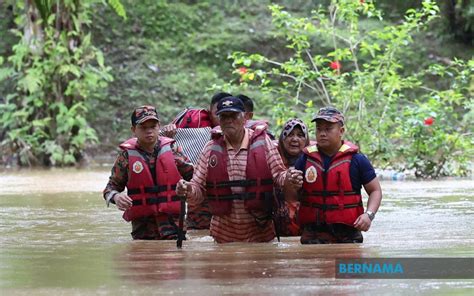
188;128;286;243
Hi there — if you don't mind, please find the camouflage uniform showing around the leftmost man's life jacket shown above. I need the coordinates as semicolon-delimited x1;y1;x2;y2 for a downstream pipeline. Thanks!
103;141;193;239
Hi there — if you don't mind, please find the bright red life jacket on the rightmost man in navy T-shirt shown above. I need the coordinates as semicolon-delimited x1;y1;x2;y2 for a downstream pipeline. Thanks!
298;141;364;226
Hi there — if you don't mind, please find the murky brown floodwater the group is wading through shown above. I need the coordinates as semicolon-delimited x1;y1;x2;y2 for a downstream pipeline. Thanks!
0;169;474;295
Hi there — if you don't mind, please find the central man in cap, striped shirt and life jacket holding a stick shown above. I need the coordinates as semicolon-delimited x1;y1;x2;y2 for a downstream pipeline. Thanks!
176;97;303;243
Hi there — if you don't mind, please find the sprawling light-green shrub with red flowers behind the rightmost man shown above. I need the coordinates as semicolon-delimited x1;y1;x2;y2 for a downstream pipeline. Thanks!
227;0;473;178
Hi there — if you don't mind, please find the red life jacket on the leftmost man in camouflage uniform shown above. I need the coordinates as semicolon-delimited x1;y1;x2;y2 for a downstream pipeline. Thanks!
120;137;181;221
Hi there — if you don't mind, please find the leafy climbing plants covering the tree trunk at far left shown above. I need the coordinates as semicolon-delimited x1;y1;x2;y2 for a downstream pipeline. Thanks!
0;1;112;165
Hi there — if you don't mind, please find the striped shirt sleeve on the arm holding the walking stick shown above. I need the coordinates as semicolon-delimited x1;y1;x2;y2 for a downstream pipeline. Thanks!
187;141;212;205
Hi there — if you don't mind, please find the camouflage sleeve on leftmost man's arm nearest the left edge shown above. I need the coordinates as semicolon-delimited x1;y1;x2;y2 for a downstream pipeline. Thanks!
103;150;128;206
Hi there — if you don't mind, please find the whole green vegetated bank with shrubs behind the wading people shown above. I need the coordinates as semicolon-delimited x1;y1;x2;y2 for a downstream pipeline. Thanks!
0;0;474;177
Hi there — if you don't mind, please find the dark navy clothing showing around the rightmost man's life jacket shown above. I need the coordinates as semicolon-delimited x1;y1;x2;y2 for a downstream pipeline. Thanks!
295;142;376;244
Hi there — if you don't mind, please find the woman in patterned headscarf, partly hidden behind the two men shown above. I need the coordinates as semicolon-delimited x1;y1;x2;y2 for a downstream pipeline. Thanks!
274;118;309;236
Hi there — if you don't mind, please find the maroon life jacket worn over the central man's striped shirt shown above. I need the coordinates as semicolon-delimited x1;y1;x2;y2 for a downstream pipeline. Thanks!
206;128;273;216
